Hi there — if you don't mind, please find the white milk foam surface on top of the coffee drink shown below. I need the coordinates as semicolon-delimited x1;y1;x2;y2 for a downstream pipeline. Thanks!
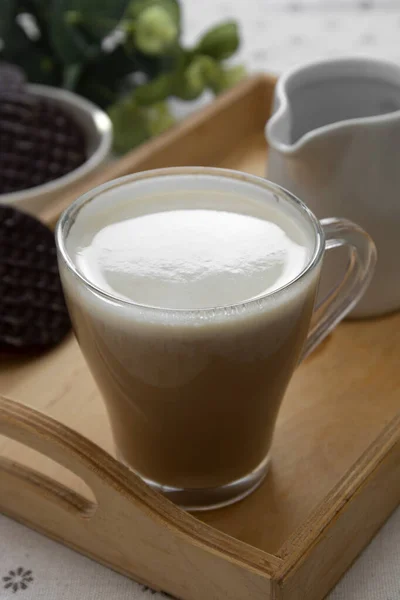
77;209;309;309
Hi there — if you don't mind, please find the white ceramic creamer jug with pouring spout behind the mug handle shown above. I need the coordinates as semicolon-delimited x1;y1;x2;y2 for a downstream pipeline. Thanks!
266;58;400;317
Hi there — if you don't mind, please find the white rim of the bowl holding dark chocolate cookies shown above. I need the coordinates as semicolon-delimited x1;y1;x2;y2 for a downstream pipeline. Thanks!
0;83;113;203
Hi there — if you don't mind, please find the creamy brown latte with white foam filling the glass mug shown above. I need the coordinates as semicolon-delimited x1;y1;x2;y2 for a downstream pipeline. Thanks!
60;173;319;507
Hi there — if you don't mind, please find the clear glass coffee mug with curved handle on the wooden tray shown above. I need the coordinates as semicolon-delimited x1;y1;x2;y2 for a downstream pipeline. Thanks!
56;167;376;510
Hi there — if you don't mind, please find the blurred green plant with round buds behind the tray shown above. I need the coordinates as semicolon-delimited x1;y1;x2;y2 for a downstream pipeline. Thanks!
0;0;243;152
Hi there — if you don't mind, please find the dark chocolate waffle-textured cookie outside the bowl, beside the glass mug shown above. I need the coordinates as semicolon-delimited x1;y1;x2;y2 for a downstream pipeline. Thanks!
0;205;71;352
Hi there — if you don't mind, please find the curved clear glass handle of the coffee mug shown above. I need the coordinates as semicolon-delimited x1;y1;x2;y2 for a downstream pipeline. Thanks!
300;218;376;360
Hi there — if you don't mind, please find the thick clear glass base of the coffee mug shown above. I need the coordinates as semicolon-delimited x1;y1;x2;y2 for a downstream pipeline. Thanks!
117;452;270;512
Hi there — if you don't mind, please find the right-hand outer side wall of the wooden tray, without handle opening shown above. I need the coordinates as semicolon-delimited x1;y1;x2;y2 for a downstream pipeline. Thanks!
273;413;400;600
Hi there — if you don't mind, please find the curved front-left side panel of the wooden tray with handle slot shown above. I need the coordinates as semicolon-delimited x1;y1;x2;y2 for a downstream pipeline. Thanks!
0;396;276;600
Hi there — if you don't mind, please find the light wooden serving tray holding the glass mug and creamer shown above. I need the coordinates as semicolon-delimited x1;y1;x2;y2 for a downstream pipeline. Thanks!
0;76;400;600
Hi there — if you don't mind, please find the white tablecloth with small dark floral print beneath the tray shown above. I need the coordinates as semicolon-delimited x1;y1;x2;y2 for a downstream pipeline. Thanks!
0;0;400;600
